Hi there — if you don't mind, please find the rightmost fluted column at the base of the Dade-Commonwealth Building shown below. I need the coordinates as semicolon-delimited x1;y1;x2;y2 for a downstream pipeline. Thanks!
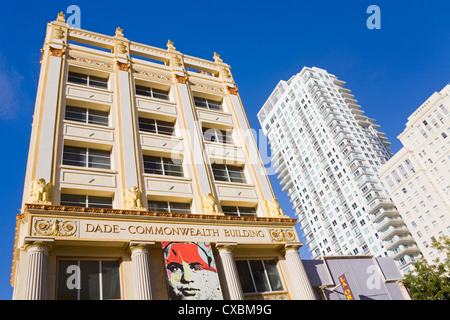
284;243;316;300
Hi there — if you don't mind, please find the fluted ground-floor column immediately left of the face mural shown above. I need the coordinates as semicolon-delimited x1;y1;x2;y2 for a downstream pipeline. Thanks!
130;241;155;300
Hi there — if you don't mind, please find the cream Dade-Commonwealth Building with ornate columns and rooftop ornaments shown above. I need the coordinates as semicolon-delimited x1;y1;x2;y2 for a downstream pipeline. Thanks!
11;13;315;299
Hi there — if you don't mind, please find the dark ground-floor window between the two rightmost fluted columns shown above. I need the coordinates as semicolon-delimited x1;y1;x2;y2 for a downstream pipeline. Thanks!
236;260;284;293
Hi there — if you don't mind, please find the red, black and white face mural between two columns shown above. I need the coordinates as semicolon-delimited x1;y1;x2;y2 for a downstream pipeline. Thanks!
162;242;222;300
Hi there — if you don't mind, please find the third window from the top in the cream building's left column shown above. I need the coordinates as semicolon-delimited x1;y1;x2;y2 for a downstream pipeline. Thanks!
63;146;111;169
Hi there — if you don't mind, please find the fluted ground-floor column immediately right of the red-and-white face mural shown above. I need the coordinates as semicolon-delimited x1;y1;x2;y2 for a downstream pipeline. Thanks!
216;243;244;300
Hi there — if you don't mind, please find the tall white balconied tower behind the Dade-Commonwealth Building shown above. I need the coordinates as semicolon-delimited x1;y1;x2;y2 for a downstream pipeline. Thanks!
258;67;418;271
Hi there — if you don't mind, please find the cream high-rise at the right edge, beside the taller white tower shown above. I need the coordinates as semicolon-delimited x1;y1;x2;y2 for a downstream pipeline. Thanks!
380;85;450;263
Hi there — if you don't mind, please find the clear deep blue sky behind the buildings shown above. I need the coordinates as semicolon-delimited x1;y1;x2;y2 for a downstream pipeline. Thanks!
0;0;450;299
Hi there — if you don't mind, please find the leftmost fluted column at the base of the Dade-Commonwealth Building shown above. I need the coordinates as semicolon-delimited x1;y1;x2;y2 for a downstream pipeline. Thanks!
23;239;54;300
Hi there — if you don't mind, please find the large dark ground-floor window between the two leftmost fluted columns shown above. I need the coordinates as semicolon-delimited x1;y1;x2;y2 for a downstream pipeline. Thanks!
56;260;121;300
